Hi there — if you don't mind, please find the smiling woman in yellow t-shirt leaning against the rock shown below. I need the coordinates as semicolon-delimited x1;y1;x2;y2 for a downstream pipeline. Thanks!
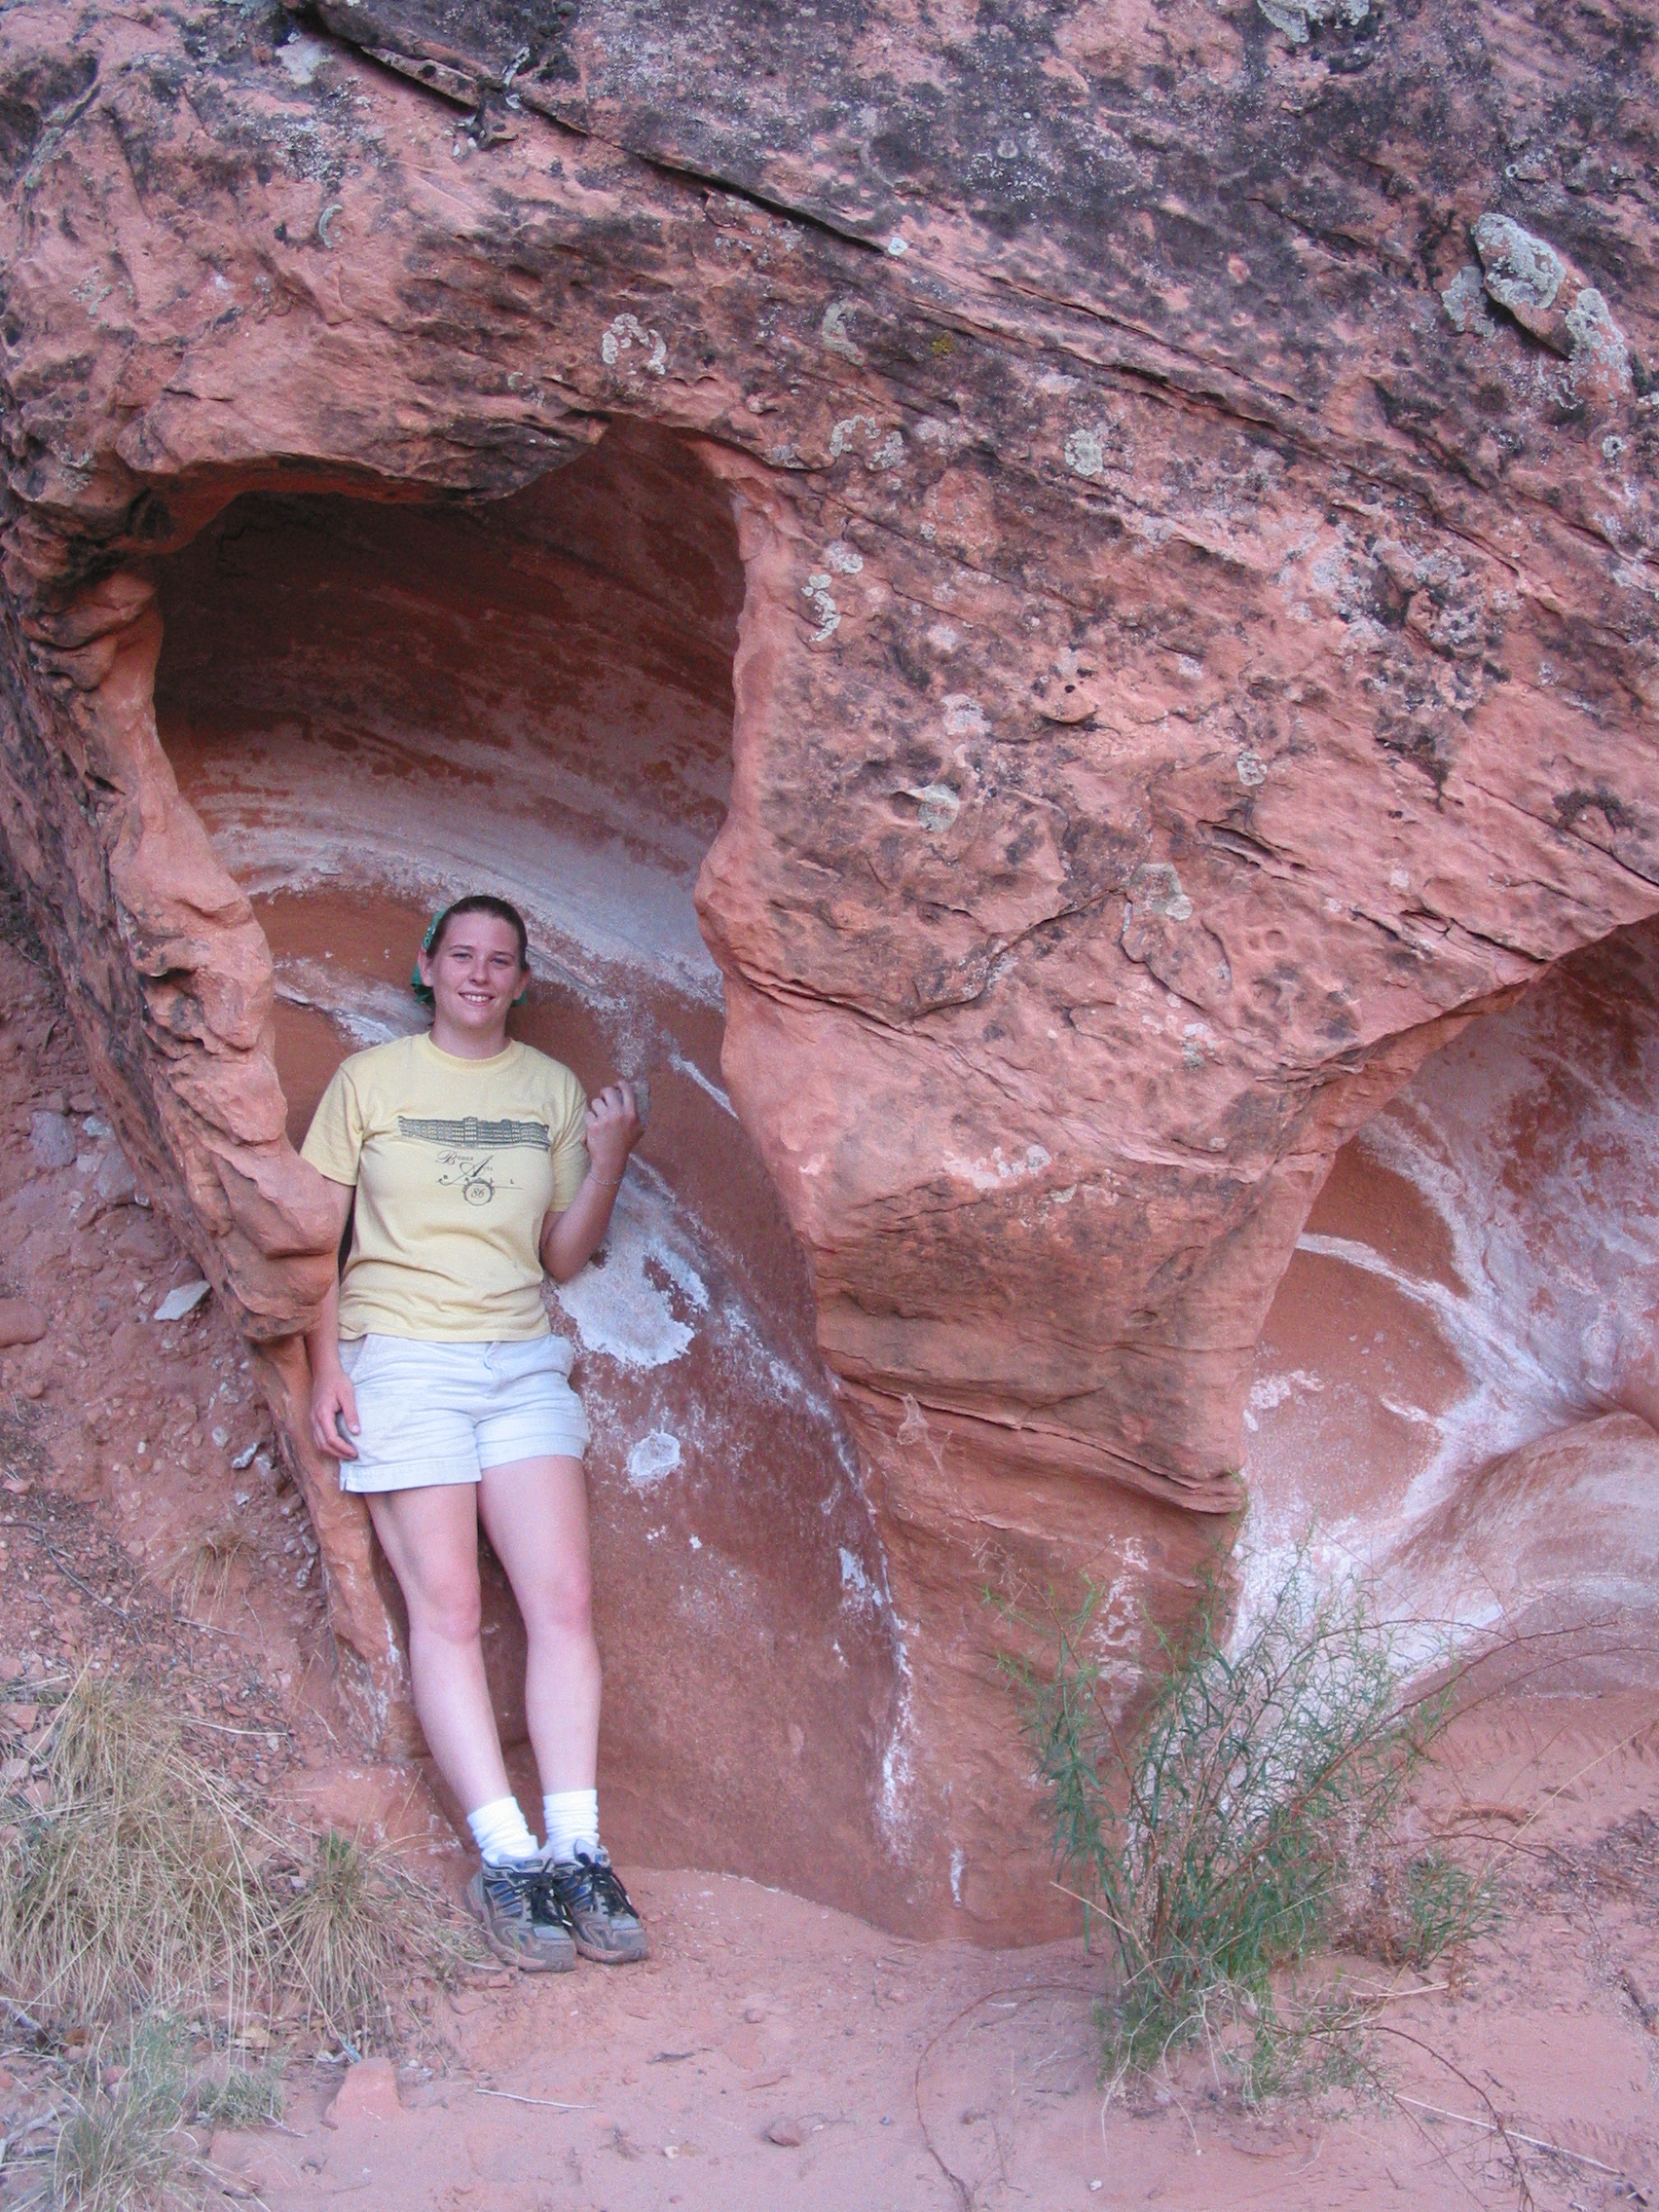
303;894;648;1971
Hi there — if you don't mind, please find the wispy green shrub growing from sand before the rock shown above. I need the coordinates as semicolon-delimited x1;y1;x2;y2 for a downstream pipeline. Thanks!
1007;1557;1493;2095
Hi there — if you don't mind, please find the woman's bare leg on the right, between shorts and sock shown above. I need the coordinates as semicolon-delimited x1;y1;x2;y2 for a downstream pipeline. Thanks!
478;1457;600;1791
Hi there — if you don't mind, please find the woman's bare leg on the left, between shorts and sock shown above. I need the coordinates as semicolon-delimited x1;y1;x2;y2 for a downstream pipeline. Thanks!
367;1482;513;1814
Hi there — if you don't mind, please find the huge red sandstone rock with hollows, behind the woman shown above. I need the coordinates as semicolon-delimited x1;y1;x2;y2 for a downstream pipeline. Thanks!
0;0;1659;1936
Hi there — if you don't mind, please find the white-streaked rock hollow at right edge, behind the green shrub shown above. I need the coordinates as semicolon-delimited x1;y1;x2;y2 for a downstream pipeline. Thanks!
1243;920;1659;1678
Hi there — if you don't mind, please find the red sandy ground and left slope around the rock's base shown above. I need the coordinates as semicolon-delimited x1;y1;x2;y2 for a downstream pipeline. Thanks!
0;916;1659;2212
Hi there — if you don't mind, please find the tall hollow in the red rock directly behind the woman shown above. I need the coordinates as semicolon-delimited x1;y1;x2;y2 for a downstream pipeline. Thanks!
155;421;896;1902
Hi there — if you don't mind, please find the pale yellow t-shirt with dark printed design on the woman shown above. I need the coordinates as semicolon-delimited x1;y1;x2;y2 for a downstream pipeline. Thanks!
301;1035;588;1343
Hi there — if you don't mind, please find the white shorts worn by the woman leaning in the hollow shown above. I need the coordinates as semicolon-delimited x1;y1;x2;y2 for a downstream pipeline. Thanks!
341;1336;588;1491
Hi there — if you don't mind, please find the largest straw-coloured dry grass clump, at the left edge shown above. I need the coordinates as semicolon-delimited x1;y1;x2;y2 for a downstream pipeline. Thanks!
0;1675;270;2022
